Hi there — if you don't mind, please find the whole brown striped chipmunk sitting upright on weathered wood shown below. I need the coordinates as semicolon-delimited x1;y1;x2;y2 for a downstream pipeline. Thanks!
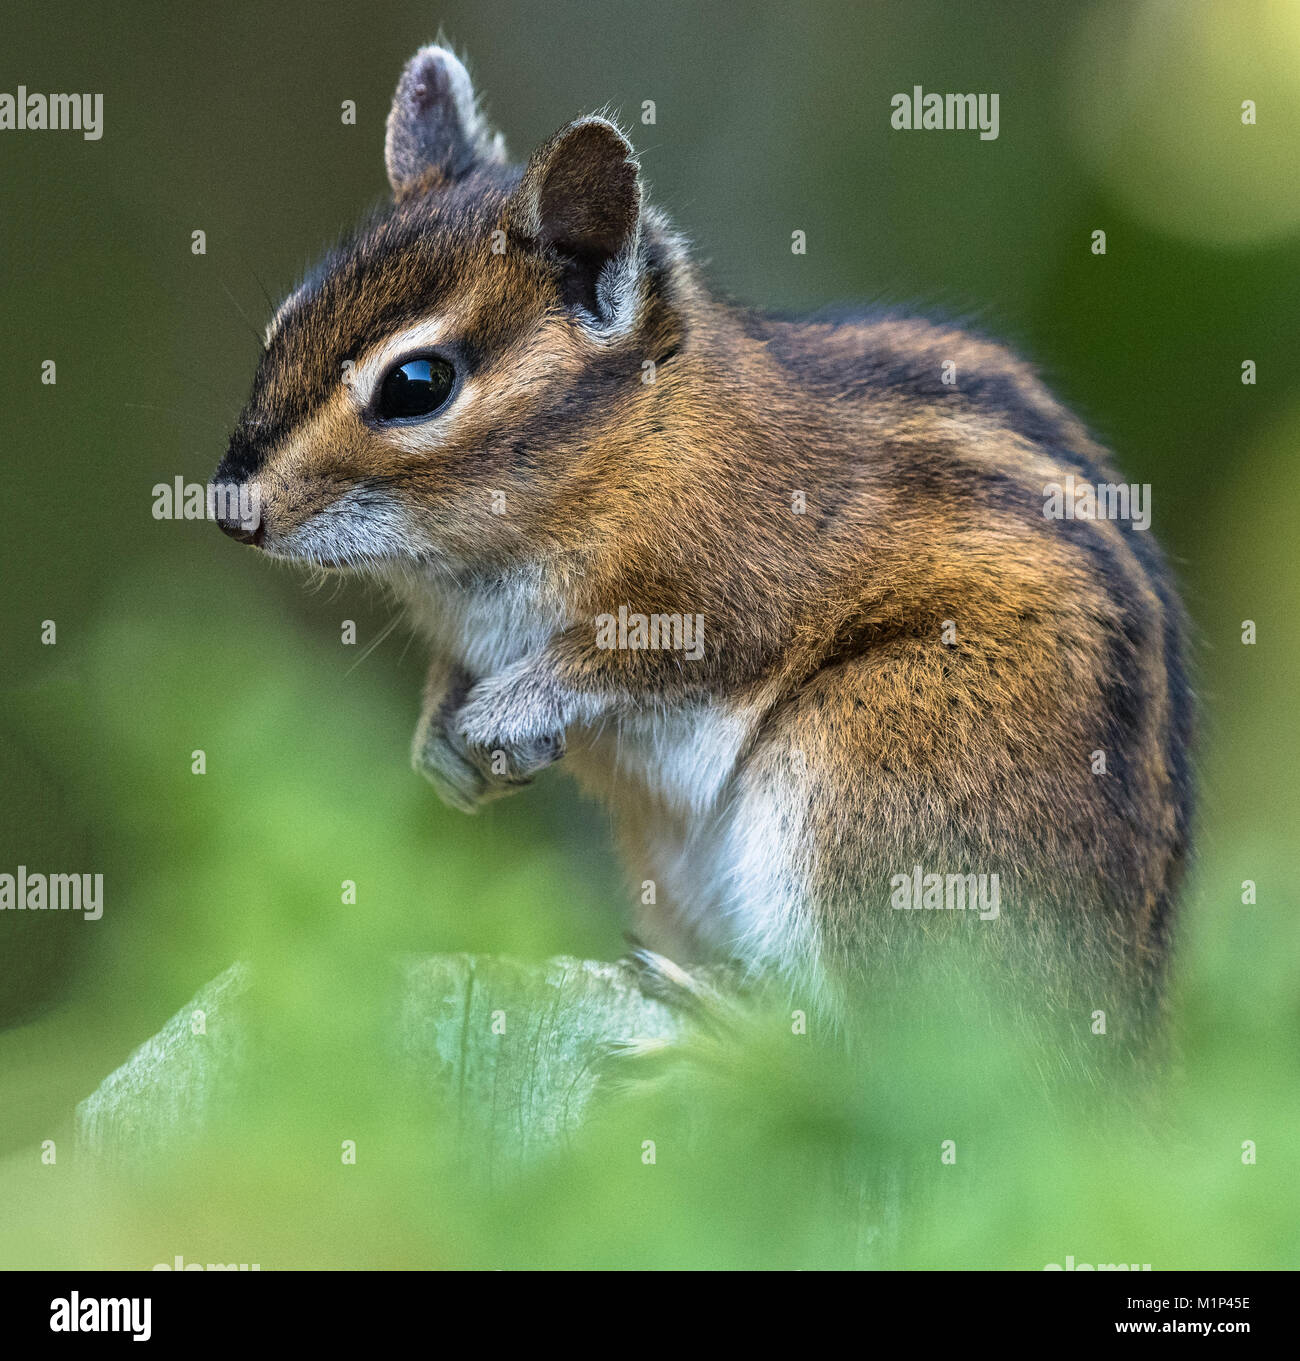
216;48;1190;1028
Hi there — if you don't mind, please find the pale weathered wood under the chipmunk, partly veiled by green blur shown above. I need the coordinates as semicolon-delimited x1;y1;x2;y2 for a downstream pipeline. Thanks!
76;954;682;1165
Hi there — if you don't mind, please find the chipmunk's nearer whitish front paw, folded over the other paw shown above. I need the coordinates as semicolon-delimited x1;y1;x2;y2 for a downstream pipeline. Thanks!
452;670;565;784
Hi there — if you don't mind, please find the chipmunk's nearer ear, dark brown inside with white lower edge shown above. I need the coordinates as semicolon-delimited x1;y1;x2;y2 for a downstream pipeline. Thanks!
509;117;641;328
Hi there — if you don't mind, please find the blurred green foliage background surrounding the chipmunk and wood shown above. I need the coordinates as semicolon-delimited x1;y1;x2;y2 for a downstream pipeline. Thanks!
0;0;1300;1267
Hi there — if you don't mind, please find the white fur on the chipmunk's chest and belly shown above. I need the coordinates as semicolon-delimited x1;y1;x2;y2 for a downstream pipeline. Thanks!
403;574;809;965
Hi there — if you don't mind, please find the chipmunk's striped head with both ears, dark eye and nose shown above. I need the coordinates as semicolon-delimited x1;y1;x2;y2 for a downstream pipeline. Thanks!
212;48;683;570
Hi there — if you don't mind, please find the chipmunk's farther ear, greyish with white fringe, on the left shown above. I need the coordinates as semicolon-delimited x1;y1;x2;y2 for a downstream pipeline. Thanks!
384;46;505;199
